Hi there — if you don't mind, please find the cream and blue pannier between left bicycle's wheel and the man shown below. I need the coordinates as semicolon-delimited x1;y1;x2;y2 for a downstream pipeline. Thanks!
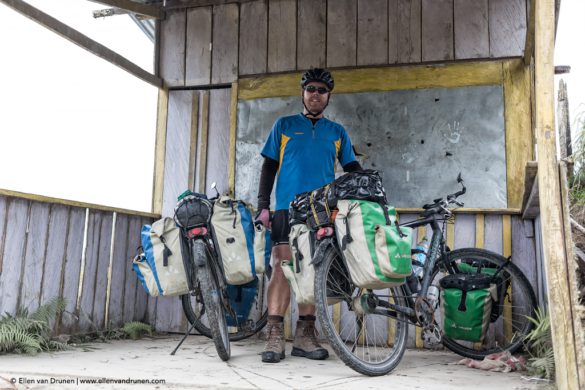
211;196;270;285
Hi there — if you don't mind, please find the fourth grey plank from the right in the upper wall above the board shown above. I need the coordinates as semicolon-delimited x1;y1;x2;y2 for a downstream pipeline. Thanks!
396;0;422;63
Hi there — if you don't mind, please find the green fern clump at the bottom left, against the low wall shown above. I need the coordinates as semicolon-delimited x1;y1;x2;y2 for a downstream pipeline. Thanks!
0;298;69;354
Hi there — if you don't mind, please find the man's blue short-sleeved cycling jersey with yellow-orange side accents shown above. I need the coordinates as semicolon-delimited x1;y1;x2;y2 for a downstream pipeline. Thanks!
262;114;356;210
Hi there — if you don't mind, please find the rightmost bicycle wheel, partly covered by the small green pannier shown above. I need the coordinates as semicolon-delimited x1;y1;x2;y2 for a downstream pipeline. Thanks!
431;248;537;360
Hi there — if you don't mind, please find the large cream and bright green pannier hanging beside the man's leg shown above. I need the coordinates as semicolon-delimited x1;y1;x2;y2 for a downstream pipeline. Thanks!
335;200;412;289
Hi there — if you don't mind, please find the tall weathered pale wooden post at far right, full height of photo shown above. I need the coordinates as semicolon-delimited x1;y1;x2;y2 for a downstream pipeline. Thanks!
534;0;579;389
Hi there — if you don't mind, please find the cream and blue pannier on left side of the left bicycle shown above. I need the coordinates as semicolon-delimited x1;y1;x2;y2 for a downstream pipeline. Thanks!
132;217;189;297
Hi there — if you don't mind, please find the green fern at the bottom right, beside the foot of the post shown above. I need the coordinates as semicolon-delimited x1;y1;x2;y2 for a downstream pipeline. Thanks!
524;308;555;380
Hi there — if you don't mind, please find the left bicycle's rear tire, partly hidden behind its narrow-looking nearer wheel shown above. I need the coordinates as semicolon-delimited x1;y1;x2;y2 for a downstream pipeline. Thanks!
181;274;268;341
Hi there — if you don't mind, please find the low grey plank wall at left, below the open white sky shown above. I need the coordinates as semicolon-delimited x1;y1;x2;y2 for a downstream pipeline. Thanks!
0;195;156;333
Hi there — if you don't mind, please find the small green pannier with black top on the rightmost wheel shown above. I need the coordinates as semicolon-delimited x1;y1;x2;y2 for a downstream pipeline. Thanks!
439;273;497;342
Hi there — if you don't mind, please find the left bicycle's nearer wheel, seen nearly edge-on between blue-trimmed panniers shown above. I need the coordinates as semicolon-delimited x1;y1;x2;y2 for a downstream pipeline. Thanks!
193;240;231;361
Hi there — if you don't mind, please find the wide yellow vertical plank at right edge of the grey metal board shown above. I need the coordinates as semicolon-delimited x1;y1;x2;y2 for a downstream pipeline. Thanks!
503;60;534;208
